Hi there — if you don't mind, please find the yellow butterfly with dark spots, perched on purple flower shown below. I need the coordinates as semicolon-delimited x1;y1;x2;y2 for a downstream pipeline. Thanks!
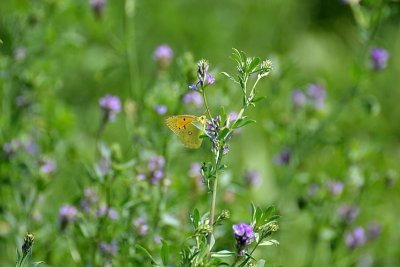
165;115;207;149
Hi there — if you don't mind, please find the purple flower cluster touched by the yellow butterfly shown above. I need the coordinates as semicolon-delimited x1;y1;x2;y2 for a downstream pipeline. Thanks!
206;115;231;155
